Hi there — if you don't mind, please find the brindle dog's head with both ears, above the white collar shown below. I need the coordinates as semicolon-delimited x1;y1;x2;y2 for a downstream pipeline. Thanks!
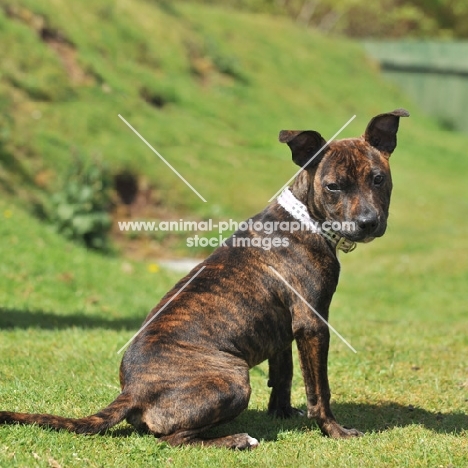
279;109;409;242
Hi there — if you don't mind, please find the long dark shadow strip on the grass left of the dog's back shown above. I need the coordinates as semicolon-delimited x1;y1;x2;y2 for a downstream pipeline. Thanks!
0;307;145;331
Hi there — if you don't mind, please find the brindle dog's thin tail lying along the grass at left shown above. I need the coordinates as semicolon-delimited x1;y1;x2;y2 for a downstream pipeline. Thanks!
0;393;132;434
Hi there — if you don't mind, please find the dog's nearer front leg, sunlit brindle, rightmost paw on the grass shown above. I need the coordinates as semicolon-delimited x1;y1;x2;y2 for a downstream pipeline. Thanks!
295;320;362;438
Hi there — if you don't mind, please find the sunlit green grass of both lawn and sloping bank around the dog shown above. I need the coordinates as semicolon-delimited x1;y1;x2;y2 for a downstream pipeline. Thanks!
0;0;468;467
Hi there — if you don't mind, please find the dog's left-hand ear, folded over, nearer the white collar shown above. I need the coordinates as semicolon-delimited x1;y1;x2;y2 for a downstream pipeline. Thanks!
279;130;327;168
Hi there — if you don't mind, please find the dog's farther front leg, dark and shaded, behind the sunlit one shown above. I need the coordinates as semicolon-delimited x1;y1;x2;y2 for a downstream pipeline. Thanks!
268;346;304;418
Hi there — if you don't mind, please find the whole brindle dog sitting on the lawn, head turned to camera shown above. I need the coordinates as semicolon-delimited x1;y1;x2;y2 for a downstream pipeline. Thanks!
0;109;409;449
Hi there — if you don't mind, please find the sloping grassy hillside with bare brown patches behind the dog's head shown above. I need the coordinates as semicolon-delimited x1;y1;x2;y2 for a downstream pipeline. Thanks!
0;0;424;216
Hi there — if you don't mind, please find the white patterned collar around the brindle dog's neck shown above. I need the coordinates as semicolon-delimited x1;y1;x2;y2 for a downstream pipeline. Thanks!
277;188;356;253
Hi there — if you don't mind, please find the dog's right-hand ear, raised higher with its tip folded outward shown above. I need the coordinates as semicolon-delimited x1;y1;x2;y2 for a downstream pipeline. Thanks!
364;109;409;155
